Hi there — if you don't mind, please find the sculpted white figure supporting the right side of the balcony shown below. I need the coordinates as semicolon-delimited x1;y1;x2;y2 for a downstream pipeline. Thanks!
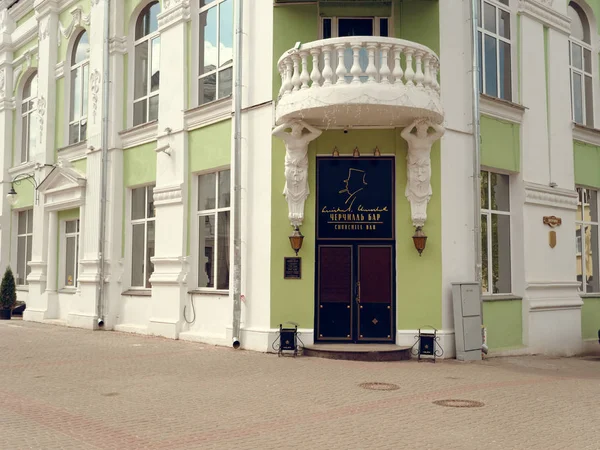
401;119;446;227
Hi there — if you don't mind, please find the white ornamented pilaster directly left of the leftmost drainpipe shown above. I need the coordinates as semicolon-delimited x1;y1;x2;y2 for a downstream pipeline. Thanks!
73;0;108;328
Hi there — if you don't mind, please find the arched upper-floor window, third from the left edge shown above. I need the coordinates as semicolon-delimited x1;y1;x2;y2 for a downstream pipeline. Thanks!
133;2;160;126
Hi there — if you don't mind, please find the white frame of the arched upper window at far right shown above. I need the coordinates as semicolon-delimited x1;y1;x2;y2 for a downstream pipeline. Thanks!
567;1;596;128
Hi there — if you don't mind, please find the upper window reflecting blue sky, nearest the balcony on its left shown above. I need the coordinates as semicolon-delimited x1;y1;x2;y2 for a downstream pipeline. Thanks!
198;0;233;105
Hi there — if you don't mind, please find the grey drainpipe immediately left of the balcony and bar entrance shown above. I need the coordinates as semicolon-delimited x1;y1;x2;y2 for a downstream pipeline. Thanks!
232;0;244;349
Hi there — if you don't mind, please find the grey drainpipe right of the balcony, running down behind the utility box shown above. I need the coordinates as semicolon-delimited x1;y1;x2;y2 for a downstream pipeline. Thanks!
471;0;483;300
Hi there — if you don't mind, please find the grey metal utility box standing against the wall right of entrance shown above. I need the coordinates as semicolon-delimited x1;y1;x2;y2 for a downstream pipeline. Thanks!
452;282;483;361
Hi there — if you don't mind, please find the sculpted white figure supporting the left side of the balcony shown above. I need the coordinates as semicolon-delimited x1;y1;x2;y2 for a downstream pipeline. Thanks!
273;120;322;227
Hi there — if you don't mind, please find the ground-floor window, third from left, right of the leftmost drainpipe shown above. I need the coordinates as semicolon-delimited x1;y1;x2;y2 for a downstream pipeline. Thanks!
131;186;155;289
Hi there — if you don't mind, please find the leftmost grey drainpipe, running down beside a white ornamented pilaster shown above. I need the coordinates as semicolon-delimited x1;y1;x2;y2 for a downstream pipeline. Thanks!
97;0;110;327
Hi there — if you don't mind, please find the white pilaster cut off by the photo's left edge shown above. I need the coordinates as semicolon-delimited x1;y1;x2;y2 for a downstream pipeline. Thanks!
0;1;15;276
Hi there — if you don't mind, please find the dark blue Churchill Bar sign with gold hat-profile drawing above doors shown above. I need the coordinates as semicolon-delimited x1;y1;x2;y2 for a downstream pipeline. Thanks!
316;156;395;240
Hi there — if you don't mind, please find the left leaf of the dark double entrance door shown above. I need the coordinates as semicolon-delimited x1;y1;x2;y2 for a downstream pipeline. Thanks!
317;245;353;341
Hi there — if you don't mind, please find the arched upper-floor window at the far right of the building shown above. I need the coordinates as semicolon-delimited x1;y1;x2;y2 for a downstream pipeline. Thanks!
568;2;594;127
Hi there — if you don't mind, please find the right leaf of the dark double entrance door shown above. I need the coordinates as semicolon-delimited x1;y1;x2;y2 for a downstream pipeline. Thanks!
357;245;394;341
